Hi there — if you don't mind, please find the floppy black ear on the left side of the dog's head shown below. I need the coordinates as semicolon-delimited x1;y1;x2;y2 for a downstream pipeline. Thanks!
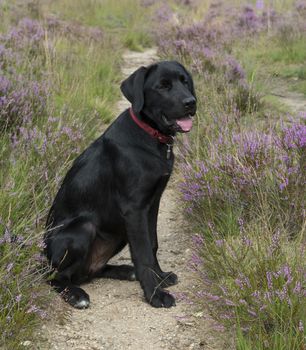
120;67;147;113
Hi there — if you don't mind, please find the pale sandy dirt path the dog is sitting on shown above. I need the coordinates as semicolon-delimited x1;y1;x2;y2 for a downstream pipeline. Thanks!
39;49;224;350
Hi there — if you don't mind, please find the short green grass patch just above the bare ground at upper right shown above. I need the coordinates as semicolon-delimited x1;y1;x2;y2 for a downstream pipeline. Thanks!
234;28;306;98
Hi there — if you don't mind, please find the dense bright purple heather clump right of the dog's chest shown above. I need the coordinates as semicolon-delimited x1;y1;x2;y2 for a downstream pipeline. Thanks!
180;121;306;229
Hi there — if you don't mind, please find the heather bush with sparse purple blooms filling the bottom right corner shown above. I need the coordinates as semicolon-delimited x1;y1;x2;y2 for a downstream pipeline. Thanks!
190;224;306;350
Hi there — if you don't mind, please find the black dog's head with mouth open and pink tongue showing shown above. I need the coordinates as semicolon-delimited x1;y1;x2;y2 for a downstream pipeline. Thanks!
121;61;196;134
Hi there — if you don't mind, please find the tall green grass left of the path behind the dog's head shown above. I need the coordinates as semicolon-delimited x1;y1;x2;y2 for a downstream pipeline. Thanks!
49;38;121;122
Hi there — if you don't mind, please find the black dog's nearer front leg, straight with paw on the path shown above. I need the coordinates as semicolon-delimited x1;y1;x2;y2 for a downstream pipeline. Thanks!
125;206;175;307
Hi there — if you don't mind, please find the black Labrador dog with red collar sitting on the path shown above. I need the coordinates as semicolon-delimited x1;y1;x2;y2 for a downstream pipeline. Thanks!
45;61;196;308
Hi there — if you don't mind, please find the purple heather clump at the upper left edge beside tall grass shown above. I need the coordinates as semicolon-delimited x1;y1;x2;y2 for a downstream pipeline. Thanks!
0;19;49;132
